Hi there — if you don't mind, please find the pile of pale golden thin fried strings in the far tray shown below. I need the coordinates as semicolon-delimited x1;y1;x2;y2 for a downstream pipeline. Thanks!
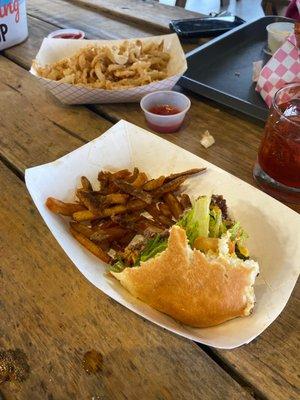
33;40;170;90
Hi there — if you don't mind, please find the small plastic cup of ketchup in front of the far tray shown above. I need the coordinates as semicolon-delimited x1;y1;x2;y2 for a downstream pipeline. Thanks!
140;91;191;133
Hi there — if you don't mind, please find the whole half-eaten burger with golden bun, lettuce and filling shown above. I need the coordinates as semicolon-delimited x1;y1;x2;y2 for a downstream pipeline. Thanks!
110;196;259;328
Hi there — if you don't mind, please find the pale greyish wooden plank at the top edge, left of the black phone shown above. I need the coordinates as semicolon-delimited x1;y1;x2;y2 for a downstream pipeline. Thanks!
66;0;203;32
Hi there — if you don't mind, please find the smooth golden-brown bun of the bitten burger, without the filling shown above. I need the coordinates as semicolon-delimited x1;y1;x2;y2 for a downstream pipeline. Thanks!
111;226;259;328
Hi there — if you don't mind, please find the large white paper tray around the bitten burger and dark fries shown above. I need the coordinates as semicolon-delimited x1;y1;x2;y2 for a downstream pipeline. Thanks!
25;121;300;349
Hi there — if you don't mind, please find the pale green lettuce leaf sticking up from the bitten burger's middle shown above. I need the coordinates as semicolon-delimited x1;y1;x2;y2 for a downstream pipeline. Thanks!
177;196;211;246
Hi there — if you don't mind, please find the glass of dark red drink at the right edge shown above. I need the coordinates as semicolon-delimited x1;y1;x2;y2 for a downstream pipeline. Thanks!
253;83;300;204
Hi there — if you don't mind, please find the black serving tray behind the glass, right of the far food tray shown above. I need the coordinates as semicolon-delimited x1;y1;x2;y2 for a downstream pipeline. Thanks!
179;16;294;121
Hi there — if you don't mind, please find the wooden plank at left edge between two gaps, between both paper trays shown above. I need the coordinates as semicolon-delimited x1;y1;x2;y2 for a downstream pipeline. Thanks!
0;56;111;171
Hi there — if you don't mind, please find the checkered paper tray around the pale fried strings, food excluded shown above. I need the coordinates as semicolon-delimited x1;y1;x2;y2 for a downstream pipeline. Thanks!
30;34;187;104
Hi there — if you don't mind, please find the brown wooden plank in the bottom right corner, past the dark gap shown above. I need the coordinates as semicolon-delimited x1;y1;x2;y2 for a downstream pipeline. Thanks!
218;282;300;400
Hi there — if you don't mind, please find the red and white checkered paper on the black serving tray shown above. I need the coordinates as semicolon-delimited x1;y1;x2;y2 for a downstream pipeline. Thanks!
256;34;300;107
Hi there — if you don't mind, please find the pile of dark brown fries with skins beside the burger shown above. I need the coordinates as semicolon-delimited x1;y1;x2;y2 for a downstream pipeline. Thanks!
46;168;205;264
